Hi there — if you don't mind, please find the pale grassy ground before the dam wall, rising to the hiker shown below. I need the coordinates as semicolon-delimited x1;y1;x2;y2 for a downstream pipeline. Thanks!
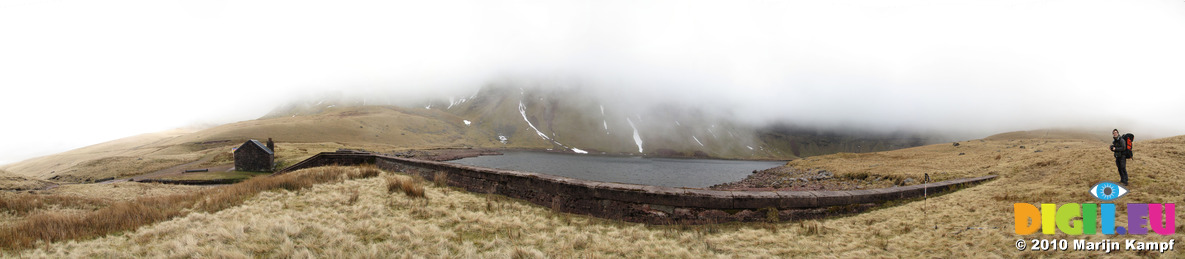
9;135;1185;258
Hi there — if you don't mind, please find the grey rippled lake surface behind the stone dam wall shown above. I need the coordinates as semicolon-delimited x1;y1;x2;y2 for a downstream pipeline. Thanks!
448;151;786;188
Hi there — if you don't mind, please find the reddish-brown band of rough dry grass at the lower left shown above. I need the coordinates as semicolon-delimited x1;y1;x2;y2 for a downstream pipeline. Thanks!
0;167;378;250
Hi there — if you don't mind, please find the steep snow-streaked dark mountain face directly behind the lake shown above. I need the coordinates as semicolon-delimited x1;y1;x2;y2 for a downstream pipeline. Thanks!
434;86;772;158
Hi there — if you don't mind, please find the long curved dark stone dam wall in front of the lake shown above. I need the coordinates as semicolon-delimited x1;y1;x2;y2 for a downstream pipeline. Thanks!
276;151;995;224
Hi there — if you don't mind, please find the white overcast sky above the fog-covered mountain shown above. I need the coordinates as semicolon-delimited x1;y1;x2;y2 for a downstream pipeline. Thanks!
0;0;1185;164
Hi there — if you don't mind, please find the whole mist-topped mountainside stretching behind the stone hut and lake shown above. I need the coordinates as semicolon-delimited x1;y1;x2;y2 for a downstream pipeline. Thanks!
2;85;931;182
